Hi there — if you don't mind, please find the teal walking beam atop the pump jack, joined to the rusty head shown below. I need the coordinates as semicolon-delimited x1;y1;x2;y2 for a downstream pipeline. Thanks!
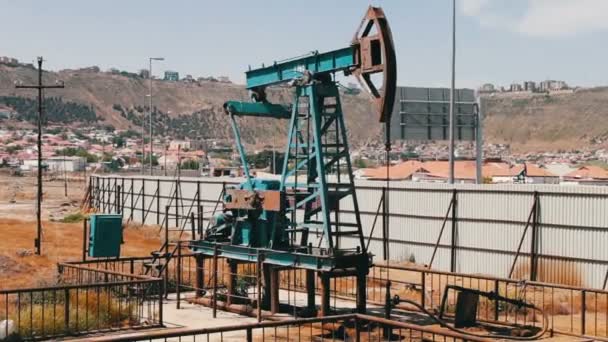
245;46;356;89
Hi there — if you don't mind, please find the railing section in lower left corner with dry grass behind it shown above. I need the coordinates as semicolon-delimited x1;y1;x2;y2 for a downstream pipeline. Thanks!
0;264;163;340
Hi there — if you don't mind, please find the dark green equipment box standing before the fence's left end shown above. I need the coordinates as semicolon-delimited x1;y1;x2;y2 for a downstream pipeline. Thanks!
89;214;123;258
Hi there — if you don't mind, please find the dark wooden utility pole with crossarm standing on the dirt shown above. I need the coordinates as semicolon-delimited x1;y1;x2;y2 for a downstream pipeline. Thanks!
15;57;63;255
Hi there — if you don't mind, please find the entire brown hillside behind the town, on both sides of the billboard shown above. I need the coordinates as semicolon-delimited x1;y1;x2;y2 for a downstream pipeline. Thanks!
0;65;608;152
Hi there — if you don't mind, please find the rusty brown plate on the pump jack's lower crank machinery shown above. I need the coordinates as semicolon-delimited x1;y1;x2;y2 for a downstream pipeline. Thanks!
224;189;282;211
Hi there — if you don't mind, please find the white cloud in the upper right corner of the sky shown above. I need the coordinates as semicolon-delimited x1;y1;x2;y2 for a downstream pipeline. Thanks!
460;0;608;37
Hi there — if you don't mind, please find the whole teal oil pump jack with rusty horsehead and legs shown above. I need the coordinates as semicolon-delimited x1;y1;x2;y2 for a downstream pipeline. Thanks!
191;6;397;315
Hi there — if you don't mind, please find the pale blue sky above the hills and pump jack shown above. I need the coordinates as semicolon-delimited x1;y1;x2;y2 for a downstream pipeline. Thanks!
0;0;608;87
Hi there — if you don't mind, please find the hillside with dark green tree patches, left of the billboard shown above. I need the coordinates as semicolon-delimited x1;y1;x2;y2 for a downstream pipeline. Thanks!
0;65;381;145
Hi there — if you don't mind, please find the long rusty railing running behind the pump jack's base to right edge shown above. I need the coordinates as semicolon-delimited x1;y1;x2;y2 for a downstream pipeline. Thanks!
61;249;608;340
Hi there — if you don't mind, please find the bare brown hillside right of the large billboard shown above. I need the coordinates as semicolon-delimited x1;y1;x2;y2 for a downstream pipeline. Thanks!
484;88;608;152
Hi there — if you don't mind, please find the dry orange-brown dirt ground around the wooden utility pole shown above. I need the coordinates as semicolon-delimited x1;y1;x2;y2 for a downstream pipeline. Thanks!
0;175;161;289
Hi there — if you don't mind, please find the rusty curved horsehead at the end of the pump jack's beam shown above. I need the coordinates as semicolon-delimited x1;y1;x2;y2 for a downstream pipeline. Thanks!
351;6;397;122
